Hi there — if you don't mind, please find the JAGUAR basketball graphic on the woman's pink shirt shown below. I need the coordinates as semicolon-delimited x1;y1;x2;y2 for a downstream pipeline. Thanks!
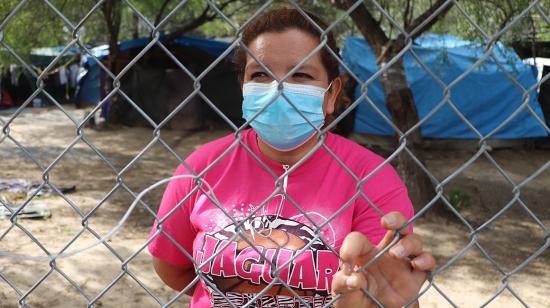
194;215;338;307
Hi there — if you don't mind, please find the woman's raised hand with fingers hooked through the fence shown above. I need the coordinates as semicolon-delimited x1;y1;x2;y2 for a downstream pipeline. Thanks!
332;212;435;308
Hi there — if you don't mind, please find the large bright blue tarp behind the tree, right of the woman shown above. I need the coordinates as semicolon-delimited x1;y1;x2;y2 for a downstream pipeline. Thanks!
342;34;547;139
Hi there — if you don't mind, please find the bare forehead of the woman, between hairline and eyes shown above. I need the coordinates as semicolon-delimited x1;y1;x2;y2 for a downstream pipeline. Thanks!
246;29;323;69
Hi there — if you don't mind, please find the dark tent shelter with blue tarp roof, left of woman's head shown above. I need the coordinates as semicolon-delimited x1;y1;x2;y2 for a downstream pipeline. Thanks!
78;37;242;130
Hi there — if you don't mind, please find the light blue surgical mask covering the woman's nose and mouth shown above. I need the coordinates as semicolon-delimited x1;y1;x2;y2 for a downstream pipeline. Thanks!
243;81;330;151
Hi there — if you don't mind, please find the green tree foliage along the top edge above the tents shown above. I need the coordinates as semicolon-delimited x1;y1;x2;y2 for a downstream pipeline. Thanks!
0;0;550;68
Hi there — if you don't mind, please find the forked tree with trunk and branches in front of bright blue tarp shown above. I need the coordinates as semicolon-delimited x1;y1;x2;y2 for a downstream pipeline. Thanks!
333;0;454;214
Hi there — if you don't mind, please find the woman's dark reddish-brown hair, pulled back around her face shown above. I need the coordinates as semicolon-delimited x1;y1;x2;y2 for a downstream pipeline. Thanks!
234;8;340;82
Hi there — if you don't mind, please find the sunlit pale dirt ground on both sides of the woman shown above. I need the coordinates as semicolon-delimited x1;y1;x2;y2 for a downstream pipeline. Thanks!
0;109;550;307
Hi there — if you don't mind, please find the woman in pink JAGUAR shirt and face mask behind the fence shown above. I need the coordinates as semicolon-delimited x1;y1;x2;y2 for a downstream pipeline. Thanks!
149;8;434;307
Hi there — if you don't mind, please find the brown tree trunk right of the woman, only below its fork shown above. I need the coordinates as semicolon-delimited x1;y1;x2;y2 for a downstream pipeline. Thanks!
380;55;435;212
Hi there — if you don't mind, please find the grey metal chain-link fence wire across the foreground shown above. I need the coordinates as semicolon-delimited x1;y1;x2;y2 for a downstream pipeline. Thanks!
0;0;550;307
